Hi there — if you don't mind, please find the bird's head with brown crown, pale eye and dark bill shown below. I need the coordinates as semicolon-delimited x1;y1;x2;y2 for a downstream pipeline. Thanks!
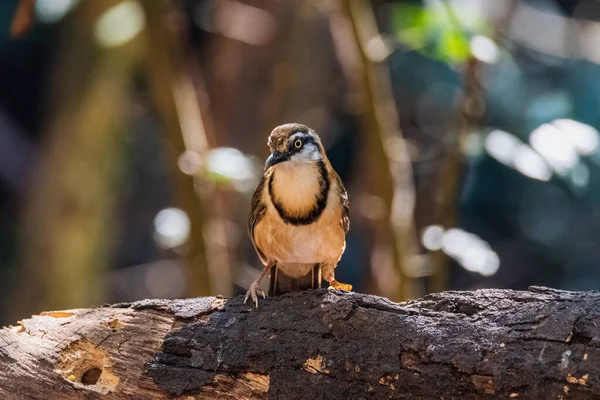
265;124;324;170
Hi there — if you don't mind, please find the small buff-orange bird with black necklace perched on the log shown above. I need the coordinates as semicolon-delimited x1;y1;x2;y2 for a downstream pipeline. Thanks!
244;123;352;308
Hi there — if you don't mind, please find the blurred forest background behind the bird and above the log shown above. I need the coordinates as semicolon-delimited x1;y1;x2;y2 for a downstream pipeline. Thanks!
0;0;600;325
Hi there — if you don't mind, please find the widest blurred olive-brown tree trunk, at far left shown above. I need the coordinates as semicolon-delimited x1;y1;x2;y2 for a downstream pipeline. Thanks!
8;0;140;317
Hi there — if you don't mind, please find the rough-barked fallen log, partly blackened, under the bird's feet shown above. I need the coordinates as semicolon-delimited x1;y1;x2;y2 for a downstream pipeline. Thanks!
0;288;600;400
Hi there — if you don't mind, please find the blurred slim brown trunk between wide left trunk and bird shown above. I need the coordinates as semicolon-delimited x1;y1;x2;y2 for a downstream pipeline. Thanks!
141;0;219;297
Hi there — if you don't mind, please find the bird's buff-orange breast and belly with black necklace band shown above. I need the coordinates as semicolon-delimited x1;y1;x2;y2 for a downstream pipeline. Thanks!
254;162;345;265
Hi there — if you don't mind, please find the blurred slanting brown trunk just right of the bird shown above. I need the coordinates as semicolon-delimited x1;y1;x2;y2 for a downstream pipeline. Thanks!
343;0;418;300
